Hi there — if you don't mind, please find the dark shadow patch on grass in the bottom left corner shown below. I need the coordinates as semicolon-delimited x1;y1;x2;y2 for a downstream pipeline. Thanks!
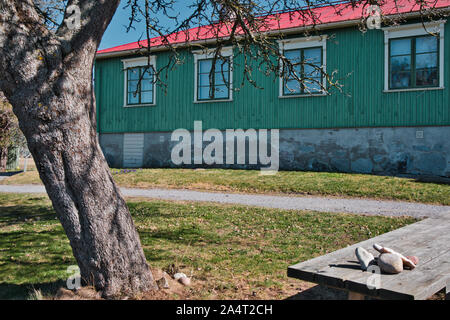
0;280;66;300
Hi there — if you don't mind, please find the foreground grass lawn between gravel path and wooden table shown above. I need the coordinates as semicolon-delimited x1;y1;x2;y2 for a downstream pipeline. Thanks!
0;194;415;299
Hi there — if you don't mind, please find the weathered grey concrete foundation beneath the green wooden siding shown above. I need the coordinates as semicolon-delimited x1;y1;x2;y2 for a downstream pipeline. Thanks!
100;126;450;177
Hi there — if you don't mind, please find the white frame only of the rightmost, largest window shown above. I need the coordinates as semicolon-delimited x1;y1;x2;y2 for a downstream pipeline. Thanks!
382;20;446;92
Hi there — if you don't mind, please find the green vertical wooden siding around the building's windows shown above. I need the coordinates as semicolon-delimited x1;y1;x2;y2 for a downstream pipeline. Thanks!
95;23;450;133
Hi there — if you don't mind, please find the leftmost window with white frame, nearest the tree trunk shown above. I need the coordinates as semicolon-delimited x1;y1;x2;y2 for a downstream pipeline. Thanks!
122;57;156;107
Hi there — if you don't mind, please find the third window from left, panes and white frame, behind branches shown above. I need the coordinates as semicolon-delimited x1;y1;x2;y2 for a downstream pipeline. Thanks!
279;36;326;97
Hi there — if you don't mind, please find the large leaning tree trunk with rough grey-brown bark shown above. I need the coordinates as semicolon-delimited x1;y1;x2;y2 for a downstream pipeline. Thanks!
0;0;155;297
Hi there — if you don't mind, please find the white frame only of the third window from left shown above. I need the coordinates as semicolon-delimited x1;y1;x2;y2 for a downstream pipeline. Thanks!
277;35;327;99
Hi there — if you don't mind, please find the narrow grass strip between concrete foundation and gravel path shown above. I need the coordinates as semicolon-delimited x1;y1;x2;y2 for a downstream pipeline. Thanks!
0;169;450;205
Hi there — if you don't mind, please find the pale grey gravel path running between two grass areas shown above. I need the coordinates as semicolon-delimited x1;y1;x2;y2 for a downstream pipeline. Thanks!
0;185;450;218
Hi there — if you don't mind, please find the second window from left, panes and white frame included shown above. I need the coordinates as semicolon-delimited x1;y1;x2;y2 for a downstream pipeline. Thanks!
194;48;233;102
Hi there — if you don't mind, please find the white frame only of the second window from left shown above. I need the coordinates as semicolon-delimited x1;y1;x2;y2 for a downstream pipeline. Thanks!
192;47;233;103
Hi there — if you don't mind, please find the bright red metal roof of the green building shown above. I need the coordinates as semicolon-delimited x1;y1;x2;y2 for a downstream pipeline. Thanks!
97;0;450;54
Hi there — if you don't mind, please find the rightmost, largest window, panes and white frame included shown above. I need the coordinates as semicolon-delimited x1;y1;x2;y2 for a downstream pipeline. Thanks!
384;23;444;91
